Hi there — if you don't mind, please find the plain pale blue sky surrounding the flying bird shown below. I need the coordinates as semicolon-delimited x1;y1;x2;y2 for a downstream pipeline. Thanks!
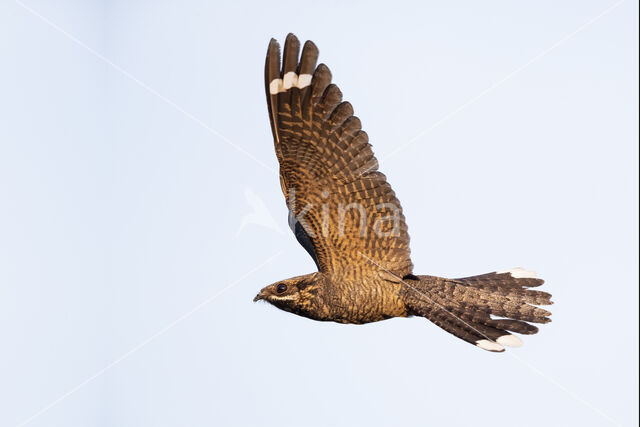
0;0;638;427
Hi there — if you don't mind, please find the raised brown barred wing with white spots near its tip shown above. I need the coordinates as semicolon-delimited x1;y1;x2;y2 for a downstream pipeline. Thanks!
265;34;413;277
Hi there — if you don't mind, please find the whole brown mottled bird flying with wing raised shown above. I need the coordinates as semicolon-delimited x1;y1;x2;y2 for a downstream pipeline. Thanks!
254;34;552;352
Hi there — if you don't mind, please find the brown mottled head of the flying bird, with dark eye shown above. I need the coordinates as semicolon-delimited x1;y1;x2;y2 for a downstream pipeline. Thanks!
253;273;325;319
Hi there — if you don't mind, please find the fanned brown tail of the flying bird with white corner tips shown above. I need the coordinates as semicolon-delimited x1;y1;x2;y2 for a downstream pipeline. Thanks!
403;268;553;352
